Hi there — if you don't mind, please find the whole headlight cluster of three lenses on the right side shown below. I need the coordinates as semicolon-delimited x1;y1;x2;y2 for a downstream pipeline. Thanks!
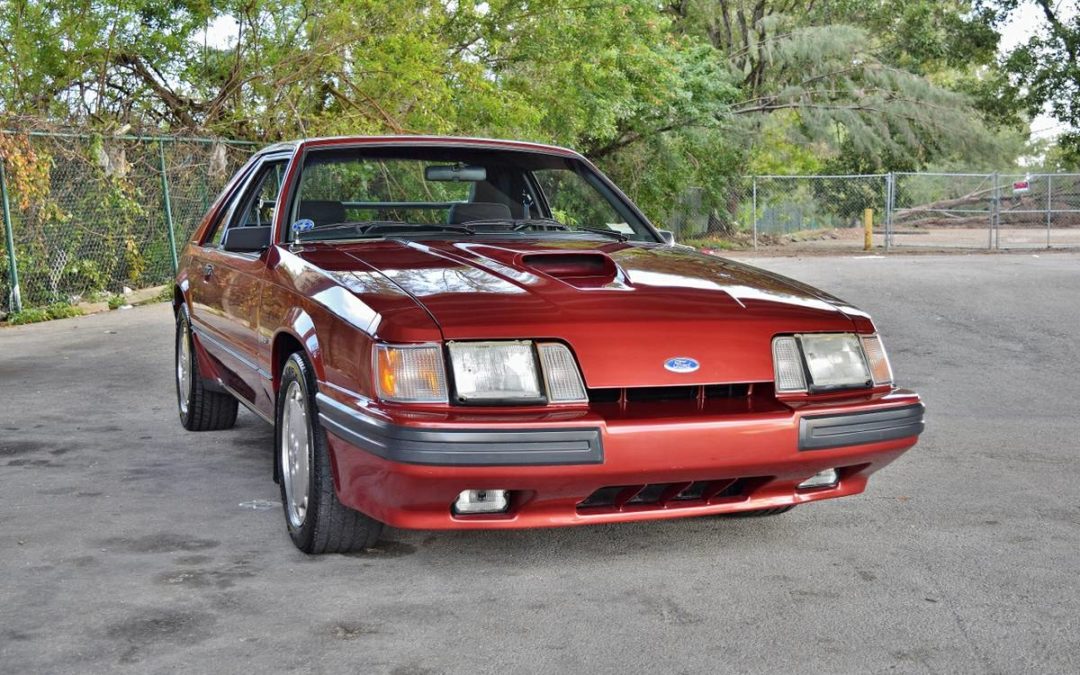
772;333;892;393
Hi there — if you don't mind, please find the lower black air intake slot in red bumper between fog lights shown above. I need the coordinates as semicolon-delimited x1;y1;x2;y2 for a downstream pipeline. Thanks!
578;478;762;512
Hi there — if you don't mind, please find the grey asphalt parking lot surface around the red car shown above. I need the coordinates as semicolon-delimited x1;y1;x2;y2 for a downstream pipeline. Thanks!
0;254;1080;673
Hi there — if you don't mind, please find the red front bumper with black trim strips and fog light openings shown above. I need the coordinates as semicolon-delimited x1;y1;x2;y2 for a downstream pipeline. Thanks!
318;390;923;529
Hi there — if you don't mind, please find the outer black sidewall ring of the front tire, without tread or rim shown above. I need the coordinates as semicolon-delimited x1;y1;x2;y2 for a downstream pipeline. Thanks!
274;353;324;550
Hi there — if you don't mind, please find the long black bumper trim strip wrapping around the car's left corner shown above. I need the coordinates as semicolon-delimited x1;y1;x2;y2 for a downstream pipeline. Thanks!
316;393;604;467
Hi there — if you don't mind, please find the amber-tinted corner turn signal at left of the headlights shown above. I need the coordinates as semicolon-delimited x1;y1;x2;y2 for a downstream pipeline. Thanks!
375;345;446;403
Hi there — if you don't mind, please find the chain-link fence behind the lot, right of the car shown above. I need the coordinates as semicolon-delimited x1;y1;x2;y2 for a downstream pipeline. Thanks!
666;173;1080;249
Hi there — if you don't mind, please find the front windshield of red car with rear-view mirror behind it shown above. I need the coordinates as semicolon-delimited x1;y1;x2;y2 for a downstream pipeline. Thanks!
286;147;657;242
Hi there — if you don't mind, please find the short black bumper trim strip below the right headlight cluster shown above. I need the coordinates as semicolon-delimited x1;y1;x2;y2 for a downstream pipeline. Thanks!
799;403;926;450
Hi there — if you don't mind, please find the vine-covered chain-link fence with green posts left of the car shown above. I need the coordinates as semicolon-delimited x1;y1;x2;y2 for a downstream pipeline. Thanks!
0;131;254;310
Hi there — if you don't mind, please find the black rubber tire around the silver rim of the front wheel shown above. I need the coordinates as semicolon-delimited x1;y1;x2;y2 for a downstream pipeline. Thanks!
274;352;382;554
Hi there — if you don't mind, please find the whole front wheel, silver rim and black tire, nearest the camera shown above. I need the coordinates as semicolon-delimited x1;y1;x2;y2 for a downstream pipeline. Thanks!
275;353;382;553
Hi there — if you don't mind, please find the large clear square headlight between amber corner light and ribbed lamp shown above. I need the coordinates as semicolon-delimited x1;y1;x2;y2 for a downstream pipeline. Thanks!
447;341;543;403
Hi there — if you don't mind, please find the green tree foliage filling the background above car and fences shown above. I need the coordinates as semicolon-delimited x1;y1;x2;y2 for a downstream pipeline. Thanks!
0;0;1045;245
